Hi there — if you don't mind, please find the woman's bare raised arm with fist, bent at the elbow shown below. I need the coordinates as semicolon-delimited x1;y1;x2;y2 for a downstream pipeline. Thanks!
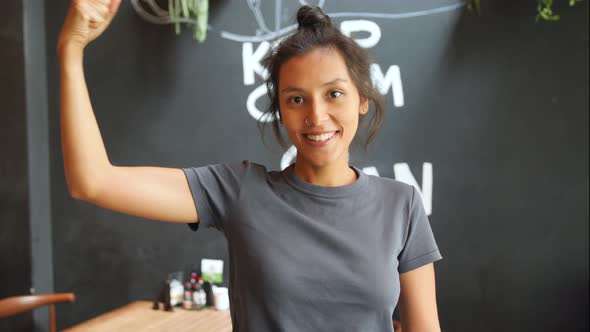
57;0;199;223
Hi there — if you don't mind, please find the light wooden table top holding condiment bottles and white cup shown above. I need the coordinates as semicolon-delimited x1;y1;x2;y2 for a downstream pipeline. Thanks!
65;301;232;332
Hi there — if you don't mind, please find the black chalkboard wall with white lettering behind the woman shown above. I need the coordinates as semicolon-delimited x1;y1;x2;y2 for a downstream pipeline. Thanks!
46;0;588;332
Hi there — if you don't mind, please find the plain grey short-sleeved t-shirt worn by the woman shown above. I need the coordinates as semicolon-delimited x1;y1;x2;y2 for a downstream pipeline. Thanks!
183;161;442;332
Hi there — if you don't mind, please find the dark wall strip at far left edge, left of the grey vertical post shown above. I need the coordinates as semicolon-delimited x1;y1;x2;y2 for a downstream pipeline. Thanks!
0;1;33;331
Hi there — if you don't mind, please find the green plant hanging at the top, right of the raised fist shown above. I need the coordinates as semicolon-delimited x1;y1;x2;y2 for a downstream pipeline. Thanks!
168;0;209;43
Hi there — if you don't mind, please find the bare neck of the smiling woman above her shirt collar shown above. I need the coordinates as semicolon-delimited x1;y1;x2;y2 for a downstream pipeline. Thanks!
293;158;357;187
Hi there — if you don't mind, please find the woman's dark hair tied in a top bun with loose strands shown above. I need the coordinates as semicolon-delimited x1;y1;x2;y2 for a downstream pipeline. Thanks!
258;6;385;149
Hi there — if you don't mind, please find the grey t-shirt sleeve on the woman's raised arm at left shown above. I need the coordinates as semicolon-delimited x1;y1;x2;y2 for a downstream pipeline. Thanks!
182;161;249;231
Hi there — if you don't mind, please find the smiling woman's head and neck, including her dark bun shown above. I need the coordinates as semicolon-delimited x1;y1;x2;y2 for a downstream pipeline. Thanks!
260;6;384;186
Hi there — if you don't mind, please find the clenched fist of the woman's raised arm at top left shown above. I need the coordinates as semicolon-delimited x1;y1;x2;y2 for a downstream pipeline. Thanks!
57;0;121;49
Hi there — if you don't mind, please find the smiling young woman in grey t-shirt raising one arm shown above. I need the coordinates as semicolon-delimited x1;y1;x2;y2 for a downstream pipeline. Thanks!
58;0;442;332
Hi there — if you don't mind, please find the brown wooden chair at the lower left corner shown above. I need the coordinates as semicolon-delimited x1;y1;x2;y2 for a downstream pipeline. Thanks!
0;293;76;332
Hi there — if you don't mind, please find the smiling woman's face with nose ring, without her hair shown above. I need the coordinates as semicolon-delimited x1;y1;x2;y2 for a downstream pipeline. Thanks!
279;48;368;167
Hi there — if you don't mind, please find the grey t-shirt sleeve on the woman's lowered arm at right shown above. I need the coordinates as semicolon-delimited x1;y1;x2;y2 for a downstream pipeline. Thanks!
398;187;442;273
